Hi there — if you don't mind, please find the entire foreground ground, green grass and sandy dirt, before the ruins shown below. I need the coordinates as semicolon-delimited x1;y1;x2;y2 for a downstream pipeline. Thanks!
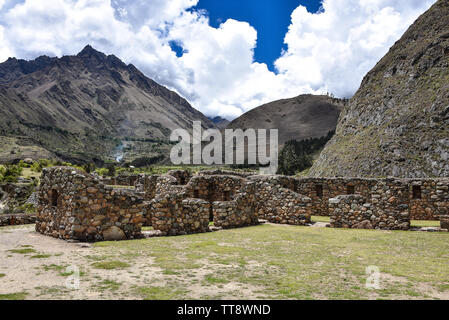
0;224;449;300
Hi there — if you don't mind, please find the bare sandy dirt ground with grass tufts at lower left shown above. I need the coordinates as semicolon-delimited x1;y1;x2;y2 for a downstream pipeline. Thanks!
0;225;154;299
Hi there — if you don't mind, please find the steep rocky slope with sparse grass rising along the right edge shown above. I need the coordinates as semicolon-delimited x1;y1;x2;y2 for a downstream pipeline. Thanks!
310;0;449;178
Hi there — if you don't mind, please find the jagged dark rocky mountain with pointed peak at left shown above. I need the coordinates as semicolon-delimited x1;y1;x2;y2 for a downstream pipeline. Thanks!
0;46;215;161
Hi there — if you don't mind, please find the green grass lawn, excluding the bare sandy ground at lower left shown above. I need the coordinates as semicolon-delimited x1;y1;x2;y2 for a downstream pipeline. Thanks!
94;224;449;299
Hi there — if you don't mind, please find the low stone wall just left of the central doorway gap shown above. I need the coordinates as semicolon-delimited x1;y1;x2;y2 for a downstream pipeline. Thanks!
149;193;210;236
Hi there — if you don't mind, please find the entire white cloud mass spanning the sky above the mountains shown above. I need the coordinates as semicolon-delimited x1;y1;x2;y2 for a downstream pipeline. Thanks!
0;0;435;119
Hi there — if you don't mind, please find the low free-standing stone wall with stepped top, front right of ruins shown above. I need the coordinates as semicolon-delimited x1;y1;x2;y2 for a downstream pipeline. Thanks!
329;195;410;230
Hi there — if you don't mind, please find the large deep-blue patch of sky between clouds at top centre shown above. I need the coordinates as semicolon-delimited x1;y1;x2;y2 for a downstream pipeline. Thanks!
189;0;321;71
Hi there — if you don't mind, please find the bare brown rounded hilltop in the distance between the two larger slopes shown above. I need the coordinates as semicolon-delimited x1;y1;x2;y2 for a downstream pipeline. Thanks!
227;95;343;145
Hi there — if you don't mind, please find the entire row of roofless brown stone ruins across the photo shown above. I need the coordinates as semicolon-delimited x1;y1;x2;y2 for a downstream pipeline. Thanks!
36;167;449;241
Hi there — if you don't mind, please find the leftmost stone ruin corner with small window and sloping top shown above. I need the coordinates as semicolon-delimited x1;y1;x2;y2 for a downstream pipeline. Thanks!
36;167;144;241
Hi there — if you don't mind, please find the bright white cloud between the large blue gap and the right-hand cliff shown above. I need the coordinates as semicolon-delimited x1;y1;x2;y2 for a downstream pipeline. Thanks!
276;0;435;97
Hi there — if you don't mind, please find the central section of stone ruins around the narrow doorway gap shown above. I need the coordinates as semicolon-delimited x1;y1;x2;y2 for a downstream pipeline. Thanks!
146;175;258;235
